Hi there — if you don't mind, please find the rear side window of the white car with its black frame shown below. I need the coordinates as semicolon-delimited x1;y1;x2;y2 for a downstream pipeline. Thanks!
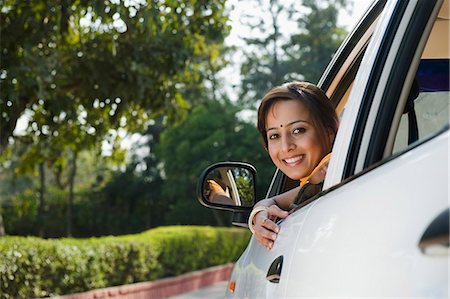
342;1;449;180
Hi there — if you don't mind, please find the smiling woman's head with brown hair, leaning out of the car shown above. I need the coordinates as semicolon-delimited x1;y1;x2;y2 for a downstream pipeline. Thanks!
258;82;338;180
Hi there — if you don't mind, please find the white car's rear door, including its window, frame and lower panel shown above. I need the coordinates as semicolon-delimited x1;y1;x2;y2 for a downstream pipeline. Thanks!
286;0;450;298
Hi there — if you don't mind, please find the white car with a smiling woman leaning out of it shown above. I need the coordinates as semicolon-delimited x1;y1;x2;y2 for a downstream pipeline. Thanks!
198;0;450;298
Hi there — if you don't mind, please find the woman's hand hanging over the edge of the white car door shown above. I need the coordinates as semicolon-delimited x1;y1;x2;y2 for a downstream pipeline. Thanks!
253;205;288;250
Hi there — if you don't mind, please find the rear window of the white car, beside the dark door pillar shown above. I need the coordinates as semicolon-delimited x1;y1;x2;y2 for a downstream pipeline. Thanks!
360;0;450;169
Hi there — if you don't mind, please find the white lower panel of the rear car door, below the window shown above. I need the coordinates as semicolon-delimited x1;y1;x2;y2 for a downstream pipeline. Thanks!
286;131;449;298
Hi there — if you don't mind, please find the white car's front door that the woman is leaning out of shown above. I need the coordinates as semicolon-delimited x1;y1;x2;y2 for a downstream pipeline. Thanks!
223;1;386;298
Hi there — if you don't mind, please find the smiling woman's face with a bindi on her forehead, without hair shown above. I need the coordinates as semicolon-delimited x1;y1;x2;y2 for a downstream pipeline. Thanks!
266;100;326;180
